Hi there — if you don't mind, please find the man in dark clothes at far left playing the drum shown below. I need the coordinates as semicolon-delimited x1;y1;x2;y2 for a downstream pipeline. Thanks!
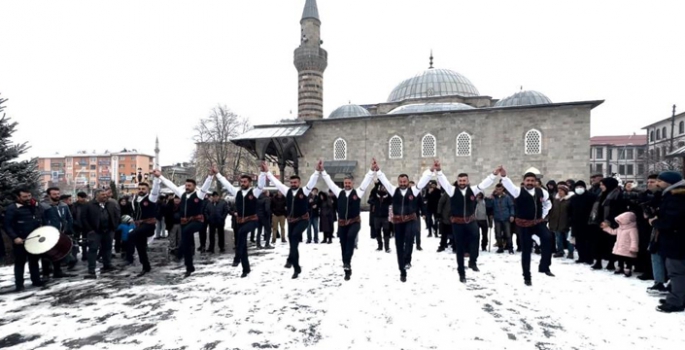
4;187;45;292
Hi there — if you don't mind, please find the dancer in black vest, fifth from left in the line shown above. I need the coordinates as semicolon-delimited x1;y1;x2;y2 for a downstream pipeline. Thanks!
316;160;374;281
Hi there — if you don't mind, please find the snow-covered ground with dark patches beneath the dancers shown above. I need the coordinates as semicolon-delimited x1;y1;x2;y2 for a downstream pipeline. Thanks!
0;213;685;350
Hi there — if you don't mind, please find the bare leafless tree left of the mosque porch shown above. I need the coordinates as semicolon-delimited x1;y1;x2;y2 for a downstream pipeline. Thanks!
194;105;257;190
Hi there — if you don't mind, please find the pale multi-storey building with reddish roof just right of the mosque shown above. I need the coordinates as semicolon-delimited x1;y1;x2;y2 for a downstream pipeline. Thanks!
590;134;647;184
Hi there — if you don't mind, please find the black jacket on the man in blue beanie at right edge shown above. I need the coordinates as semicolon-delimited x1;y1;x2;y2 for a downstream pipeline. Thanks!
652;180;685;260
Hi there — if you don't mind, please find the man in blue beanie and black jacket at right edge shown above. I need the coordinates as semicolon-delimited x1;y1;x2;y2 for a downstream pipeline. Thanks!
649;171;685;313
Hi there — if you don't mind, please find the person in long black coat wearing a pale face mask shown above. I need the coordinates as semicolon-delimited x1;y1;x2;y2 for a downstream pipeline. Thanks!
568;180;597;264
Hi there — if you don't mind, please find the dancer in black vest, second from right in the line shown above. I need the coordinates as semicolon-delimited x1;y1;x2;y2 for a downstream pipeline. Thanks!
433;160;500;283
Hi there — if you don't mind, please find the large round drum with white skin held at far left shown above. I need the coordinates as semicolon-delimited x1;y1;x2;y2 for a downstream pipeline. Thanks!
24;226;74;261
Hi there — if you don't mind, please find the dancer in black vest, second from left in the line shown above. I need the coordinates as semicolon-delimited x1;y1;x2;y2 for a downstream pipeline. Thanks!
152;170;212;277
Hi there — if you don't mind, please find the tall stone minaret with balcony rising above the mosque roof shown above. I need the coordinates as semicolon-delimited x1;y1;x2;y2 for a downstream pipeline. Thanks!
295;0;328;120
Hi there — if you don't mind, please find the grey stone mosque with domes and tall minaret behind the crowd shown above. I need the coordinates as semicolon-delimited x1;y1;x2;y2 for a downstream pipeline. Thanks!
232;0;604;183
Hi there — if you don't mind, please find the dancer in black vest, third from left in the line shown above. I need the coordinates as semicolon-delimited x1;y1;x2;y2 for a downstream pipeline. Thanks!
210;167;265;278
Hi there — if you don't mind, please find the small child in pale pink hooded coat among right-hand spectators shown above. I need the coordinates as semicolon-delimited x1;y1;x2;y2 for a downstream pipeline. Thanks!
602;212;638;277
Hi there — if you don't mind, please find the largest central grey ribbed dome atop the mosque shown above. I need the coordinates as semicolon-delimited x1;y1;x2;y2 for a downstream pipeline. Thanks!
388;68;480;102
